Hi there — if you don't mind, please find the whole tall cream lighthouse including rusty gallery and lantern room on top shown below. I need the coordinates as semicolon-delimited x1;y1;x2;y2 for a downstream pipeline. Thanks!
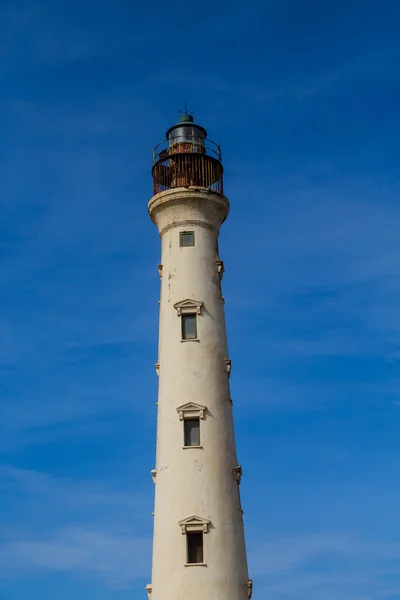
147;114;252;600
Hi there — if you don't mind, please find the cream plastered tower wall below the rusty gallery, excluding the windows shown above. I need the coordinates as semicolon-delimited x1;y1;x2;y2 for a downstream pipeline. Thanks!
149;188;248;600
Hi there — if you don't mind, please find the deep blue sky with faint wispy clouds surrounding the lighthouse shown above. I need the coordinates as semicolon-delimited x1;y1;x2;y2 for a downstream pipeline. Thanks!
0;0;400;600
